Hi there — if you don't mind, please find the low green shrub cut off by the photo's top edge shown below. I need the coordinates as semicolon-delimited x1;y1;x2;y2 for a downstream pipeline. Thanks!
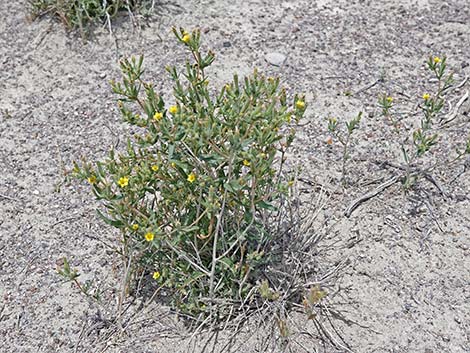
30;0;148;33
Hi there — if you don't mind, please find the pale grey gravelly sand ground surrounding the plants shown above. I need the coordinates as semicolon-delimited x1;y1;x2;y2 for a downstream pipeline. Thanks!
0;0;470;353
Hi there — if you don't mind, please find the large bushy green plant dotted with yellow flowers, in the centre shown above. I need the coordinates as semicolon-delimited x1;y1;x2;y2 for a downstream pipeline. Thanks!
70;29;306;315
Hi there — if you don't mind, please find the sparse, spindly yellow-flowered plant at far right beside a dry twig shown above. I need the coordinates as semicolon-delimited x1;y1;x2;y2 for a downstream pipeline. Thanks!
379;56;470;190
